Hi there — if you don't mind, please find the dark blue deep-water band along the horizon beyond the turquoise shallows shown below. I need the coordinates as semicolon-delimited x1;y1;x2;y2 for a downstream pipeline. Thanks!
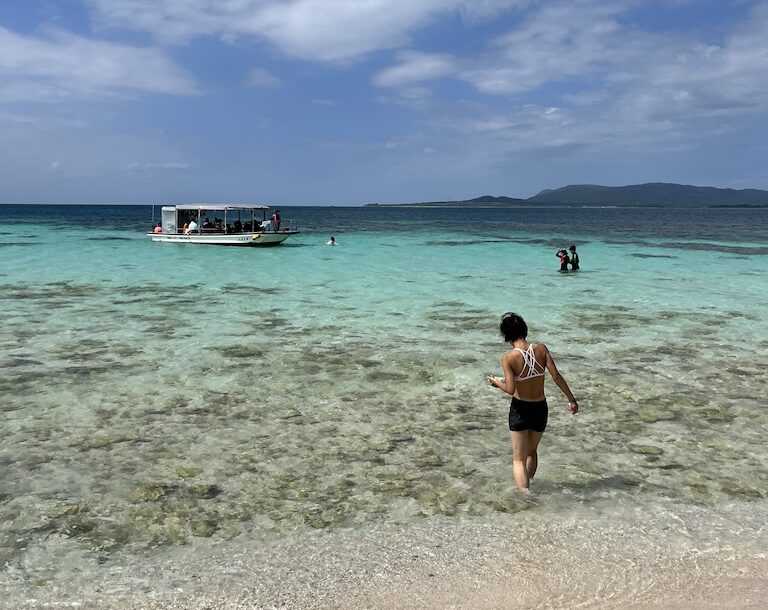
0;205;768;243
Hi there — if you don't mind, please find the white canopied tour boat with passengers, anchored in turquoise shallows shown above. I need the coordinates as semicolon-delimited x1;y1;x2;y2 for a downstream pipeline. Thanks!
147;203;299;246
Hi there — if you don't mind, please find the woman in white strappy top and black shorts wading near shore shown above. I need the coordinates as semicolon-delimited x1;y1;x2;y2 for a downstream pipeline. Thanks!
486;312;579;492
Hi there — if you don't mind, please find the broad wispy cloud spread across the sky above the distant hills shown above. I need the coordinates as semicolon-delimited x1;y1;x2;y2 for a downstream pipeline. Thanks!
374;0;768;150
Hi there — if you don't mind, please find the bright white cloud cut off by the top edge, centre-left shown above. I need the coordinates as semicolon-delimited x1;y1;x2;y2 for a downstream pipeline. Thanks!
87;0;528;62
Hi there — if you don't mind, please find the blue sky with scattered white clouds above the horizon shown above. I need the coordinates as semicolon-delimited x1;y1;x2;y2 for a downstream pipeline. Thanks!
0;0;768;205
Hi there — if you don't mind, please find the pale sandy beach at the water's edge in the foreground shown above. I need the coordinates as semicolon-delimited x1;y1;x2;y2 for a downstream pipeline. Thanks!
3;498;768;610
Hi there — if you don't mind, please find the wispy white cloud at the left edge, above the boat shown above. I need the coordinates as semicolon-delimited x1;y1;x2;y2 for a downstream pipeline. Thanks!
0;27;197;102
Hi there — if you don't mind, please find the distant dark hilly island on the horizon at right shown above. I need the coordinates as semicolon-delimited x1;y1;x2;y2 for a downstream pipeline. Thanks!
366;182;768;208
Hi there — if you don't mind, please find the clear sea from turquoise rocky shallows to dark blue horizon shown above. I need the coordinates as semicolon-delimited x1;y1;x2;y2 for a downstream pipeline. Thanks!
0;205;768;607
